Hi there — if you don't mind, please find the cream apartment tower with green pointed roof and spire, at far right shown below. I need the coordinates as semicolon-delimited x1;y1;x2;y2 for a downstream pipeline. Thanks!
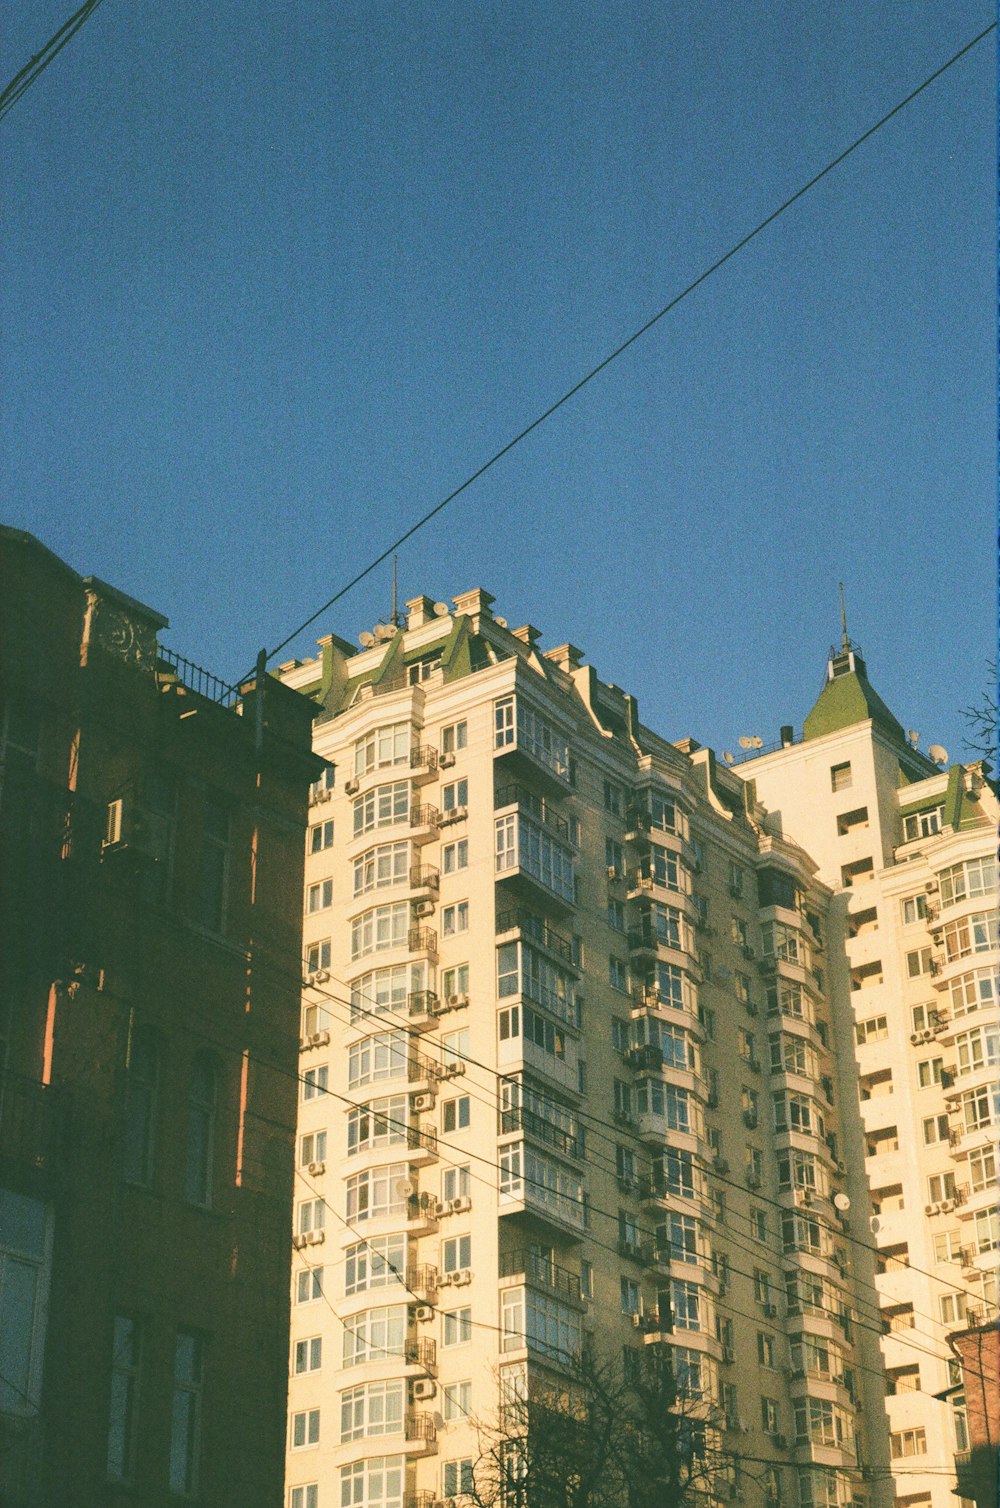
739;635;1000;1508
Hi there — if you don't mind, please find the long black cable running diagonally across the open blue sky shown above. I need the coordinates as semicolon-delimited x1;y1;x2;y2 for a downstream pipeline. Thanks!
256;21;997;679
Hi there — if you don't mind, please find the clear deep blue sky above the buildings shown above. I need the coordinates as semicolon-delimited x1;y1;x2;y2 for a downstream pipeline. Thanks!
0;0;995;757
